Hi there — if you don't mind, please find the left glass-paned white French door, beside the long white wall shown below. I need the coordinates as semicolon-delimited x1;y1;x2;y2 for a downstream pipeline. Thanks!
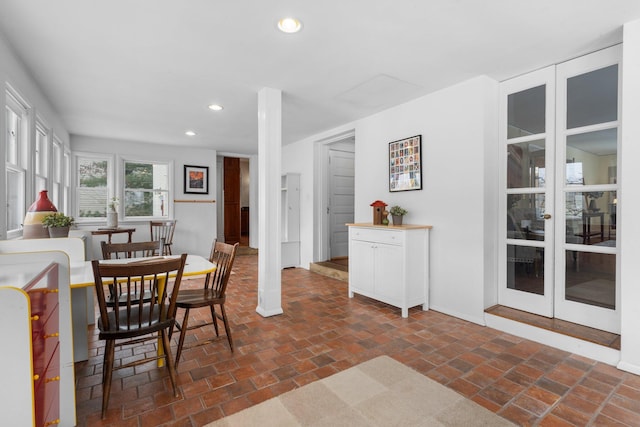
498;67;555;317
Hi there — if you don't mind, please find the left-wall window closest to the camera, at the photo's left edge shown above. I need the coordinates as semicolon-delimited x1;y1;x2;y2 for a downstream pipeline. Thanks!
6;90;28;238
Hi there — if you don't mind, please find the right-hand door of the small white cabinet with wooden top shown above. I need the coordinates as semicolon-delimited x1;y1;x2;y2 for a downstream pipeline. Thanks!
375;243;404;302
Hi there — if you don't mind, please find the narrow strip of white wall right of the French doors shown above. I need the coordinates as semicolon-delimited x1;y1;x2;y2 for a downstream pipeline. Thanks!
616;21;640;374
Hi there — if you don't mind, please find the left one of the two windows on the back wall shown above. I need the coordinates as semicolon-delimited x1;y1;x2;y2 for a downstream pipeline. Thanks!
76;155;111;218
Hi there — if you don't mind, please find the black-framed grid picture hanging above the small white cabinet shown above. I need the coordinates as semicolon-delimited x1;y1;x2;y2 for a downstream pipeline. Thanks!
389;135;422;193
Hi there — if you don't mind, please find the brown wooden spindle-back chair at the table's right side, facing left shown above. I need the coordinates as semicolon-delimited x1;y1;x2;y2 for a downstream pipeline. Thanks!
171;241;239;367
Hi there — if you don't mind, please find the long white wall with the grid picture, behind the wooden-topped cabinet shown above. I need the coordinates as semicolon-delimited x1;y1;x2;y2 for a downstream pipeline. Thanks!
283;77;498;324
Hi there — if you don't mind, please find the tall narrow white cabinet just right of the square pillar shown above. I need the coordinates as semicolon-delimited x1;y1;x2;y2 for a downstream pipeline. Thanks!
281;173;300;268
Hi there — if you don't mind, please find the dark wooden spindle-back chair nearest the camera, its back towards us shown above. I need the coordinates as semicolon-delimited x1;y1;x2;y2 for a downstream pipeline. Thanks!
92;254;187;419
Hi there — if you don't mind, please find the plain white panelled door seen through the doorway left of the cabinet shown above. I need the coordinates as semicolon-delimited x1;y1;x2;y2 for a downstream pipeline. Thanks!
329;149;355;258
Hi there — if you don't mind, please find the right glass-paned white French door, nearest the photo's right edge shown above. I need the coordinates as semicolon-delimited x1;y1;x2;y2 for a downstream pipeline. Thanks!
555;46;622;333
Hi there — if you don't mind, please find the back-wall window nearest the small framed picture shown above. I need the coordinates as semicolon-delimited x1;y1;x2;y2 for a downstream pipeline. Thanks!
123;160;171;218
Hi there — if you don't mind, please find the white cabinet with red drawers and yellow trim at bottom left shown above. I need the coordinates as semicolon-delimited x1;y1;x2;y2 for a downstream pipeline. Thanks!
0;251;77;427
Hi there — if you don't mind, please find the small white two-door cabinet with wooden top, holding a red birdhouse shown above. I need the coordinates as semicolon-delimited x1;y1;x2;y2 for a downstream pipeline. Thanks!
347;224;431;317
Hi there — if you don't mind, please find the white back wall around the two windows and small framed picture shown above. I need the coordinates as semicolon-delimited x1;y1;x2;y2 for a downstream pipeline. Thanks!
71;135;217;257
